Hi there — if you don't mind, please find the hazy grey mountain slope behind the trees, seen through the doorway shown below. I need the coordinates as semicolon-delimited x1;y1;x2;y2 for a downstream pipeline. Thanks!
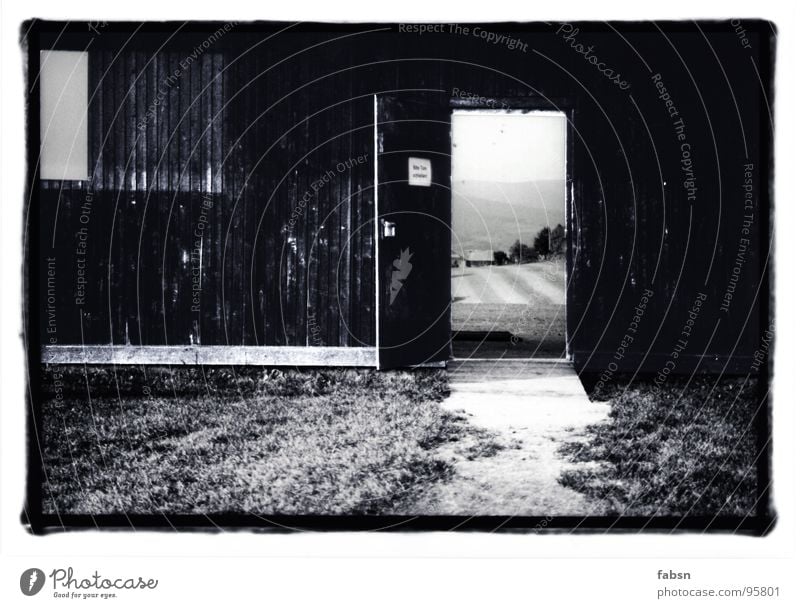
453;180;566;253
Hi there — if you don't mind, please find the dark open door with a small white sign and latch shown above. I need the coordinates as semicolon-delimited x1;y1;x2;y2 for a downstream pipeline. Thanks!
375;92;450;369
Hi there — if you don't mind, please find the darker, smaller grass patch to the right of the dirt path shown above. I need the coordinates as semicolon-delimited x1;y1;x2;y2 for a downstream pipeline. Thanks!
559;377;766;516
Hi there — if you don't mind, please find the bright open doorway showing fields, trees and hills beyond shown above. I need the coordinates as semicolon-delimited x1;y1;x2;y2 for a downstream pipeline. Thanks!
451;109;567;358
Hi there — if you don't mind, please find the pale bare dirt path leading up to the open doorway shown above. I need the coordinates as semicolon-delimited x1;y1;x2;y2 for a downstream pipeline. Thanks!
410;361;608;516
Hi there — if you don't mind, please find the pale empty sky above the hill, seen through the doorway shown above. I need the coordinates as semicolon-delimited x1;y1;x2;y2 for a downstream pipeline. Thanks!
452;110;567;183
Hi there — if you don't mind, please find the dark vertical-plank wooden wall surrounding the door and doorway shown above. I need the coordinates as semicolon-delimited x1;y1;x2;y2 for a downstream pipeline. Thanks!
32;22;773;371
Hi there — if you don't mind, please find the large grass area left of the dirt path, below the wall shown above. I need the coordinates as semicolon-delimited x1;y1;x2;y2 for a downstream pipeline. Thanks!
42;367;498;514
